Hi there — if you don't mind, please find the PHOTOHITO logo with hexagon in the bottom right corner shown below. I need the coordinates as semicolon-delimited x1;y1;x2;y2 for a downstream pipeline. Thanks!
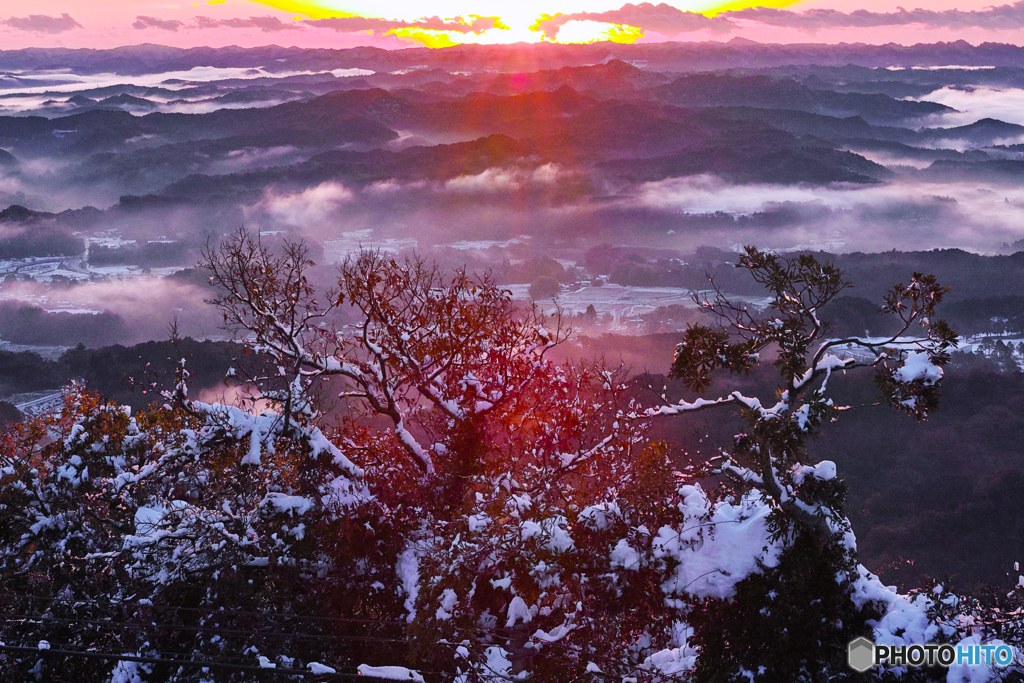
847;637;1014;672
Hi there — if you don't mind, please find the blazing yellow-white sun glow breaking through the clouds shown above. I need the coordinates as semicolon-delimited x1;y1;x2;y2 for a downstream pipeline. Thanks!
245;0;798;47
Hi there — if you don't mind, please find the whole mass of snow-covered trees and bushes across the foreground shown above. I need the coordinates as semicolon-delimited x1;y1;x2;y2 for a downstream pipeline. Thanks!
0;232;1019;683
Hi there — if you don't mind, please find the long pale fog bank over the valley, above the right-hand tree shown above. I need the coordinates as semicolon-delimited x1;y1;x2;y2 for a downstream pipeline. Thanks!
624;175;1024;252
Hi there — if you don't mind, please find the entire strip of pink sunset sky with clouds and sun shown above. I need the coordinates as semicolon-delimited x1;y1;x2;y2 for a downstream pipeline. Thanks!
0;0;1024;49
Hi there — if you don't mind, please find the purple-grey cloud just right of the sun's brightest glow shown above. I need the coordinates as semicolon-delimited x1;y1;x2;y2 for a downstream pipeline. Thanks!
531;2;736;39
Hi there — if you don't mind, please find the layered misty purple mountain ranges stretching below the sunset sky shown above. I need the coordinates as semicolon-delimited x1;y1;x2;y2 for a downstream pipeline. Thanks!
0;40;1024;255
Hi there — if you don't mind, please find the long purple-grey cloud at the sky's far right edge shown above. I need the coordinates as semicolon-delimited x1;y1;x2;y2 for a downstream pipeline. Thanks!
719;0;1024;32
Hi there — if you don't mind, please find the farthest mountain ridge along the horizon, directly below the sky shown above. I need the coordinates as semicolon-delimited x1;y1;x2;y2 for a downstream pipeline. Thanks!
8;38;1024;75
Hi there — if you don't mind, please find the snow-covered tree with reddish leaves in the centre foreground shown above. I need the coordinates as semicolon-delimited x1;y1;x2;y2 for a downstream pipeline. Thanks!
200;234;681;680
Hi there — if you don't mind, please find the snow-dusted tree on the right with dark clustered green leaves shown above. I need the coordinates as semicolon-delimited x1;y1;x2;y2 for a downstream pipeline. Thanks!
646;248;956;681
